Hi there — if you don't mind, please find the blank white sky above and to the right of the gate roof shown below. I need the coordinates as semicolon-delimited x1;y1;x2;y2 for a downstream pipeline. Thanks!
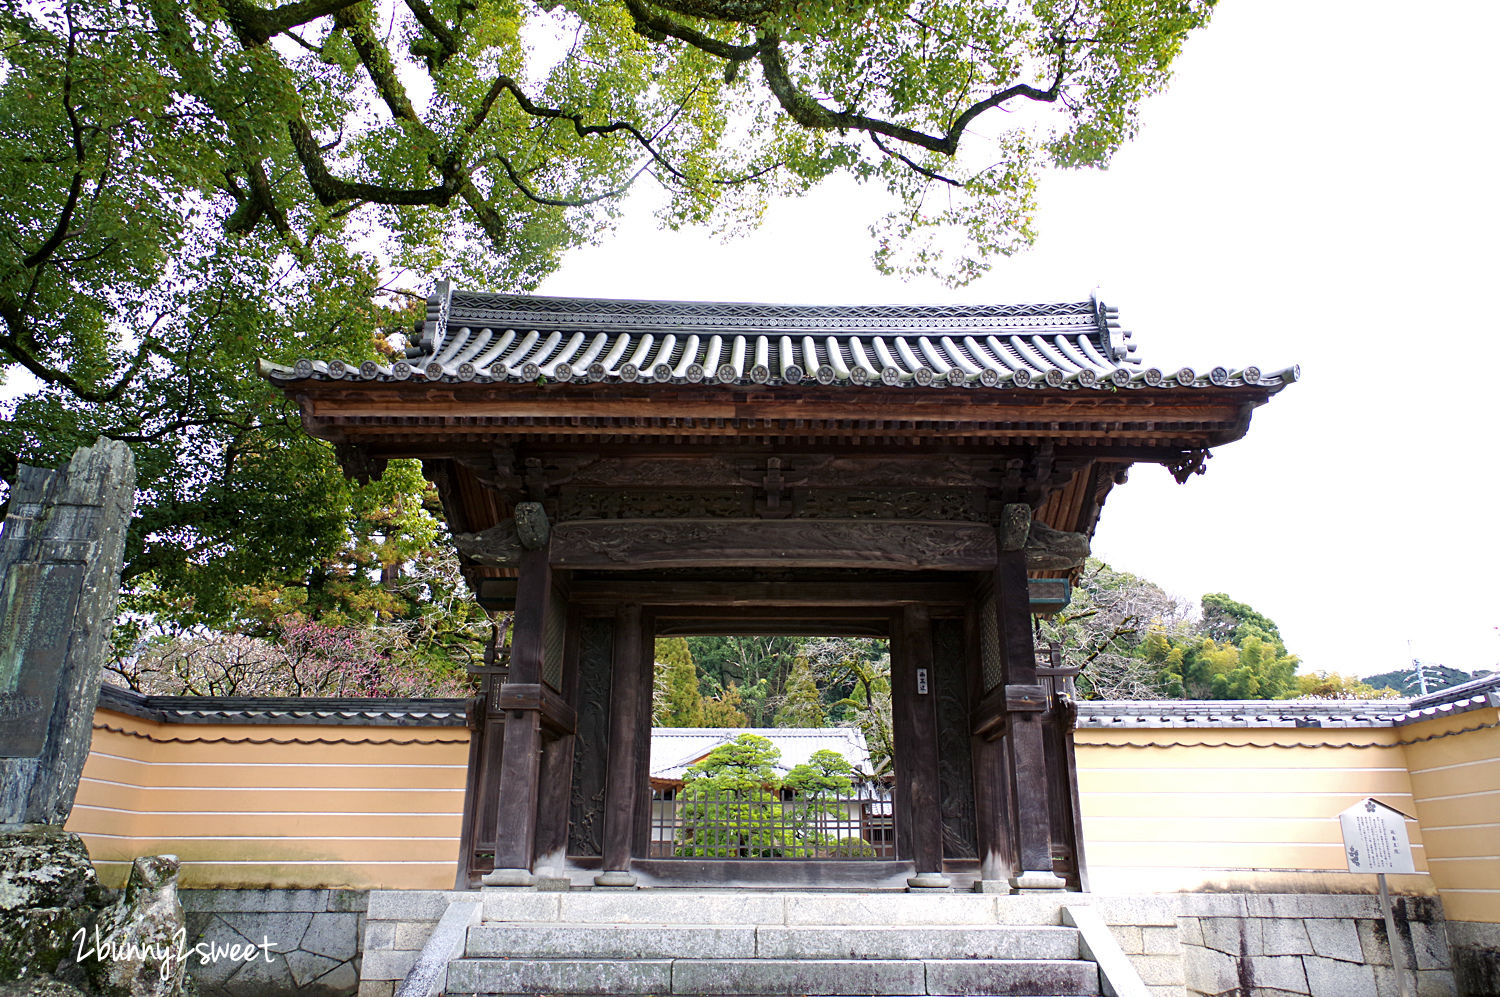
540;0;1500;675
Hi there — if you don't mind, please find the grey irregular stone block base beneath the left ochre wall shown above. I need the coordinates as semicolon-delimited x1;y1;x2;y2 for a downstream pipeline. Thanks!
179;889;369;997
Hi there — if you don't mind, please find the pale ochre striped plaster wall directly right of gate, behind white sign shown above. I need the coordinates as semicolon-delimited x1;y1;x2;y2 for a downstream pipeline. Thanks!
1077;727;1436;894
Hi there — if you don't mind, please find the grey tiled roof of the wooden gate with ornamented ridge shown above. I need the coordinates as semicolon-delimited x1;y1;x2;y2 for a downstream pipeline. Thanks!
261;282;1299;390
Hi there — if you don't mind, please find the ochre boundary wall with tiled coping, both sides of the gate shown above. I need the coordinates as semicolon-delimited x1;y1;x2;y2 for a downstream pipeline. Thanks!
68;676;1500;924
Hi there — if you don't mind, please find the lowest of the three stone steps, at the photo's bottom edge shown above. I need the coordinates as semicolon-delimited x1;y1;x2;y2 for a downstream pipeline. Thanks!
446;958;1100;997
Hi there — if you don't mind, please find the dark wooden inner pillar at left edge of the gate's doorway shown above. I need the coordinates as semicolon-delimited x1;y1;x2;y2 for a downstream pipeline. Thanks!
594;606;651;886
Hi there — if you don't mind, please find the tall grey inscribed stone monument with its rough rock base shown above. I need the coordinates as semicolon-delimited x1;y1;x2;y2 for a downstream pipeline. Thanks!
0;439;135;981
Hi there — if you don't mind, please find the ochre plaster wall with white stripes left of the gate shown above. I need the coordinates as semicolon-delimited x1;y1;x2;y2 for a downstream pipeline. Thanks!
68;711;468;889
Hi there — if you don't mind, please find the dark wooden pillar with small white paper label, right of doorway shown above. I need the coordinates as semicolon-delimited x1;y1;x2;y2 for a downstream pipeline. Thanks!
891;606;948;889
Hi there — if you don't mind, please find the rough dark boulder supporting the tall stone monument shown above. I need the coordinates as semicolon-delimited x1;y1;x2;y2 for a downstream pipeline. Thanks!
0;825;105;982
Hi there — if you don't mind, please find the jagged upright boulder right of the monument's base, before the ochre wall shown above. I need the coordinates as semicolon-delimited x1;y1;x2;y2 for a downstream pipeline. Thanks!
75;855;188;997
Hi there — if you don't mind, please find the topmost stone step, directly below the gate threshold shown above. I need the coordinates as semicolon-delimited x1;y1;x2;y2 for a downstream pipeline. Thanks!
483;891;1064;925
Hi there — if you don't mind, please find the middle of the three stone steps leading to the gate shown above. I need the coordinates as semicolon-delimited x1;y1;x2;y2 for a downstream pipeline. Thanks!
465;922;1079;960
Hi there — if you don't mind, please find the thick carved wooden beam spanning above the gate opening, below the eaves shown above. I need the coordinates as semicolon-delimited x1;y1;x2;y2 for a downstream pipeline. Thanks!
552;519;996;571
